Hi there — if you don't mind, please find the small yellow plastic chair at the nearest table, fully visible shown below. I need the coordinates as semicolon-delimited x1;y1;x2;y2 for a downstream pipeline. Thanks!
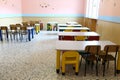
62;51;79;75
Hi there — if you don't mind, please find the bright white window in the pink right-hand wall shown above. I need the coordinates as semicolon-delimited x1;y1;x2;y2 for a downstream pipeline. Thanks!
85;0;100;19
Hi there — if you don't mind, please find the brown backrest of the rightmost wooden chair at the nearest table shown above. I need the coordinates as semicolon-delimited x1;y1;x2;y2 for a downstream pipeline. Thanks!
104;45;120;57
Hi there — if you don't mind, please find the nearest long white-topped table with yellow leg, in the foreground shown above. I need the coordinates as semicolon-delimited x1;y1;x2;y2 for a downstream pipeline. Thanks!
56;41;116;73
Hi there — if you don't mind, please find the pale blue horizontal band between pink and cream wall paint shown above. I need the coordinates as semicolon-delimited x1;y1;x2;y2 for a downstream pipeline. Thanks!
0;14;120;23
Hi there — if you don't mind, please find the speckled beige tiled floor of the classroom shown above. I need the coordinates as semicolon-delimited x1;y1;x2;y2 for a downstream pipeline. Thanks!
0;32;120;80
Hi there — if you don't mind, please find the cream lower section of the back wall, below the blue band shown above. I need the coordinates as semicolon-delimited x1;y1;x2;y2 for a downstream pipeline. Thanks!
23;17;83;30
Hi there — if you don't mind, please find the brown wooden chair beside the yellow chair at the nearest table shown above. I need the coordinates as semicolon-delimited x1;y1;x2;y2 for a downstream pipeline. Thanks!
81;45;101;76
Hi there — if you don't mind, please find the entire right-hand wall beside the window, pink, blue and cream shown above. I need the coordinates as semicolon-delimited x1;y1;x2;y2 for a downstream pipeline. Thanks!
96;0;120;44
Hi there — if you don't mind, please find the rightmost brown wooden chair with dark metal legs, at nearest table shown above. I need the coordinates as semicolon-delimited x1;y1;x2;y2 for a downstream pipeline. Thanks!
99;45;120;76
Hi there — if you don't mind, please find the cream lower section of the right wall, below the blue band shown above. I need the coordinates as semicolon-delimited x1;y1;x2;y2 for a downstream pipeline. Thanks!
97;20;120;44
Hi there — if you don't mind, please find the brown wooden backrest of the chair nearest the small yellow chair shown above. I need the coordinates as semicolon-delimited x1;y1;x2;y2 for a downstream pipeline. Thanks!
85;45;101;55
